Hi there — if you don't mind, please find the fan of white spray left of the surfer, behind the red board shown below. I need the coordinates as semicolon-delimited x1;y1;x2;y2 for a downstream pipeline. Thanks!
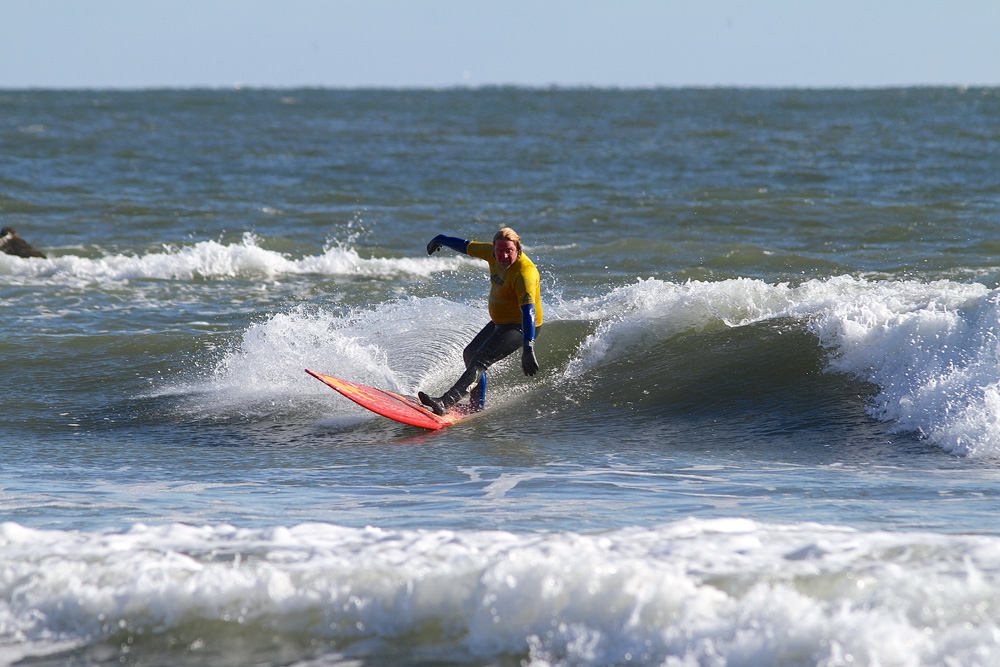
167;297;482;421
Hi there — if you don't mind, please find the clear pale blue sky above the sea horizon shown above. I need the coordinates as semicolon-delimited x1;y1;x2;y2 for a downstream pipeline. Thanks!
0;0;1000;88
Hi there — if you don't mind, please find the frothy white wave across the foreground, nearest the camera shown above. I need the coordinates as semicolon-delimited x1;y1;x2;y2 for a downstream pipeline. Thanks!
0;519;1000;667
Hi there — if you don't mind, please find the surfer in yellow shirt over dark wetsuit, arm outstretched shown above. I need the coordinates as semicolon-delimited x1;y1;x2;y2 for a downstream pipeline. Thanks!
417;227;542;415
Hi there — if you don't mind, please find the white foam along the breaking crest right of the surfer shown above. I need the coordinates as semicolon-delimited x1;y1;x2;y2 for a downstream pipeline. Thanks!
567;276;1000;457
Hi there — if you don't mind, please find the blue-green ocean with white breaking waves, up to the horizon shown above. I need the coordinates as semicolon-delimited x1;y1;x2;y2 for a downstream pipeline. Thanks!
0;87;1000;667
